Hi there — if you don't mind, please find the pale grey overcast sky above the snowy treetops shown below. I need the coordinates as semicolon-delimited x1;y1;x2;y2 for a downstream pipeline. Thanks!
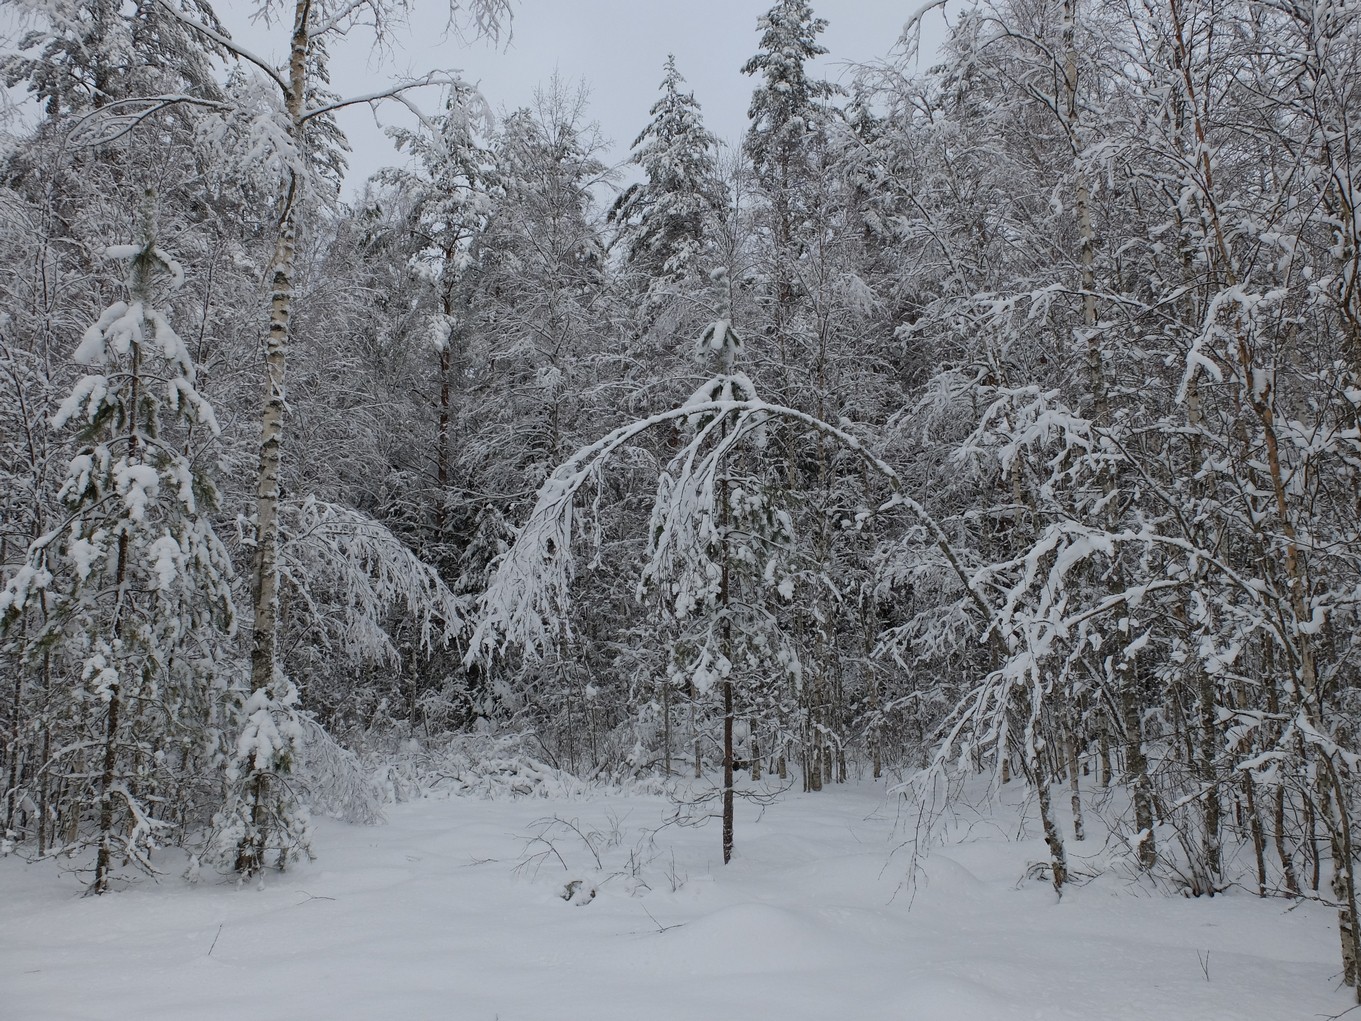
225;0;939;189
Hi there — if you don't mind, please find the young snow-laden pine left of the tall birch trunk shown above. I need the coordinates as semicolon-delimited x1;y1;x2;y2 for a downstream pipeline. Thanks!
0;200;234;893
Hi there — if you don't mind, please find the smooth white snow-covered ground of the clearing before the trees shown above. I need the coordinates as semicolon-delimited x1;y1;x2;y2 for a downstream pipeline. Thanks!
0;783;1350;1021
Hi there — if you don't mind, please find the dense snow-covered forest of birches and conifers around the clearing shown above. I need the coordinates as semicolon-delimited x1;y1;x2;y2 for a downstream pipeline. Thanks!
0;0;1361;1017
